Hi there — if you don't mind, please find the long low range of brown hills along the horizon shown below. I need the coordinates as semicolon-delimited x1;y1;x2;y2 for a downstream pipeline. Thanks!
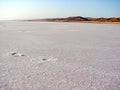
29;16;120;22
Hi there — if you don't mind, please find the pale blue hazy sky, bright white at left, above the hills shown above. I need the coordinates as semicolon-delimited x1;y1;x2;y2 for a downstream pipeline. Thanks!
0;0;120;20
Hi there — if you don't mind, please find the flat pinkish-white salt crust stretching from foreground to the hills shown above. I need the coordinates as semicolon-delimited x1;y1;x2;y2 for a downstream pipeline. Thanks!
0;21;120;90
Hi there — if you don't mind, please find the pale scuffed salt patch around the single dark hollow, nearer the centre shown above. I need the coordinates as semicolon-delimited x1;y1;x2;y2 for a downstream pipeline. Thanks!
31;56;57;63
